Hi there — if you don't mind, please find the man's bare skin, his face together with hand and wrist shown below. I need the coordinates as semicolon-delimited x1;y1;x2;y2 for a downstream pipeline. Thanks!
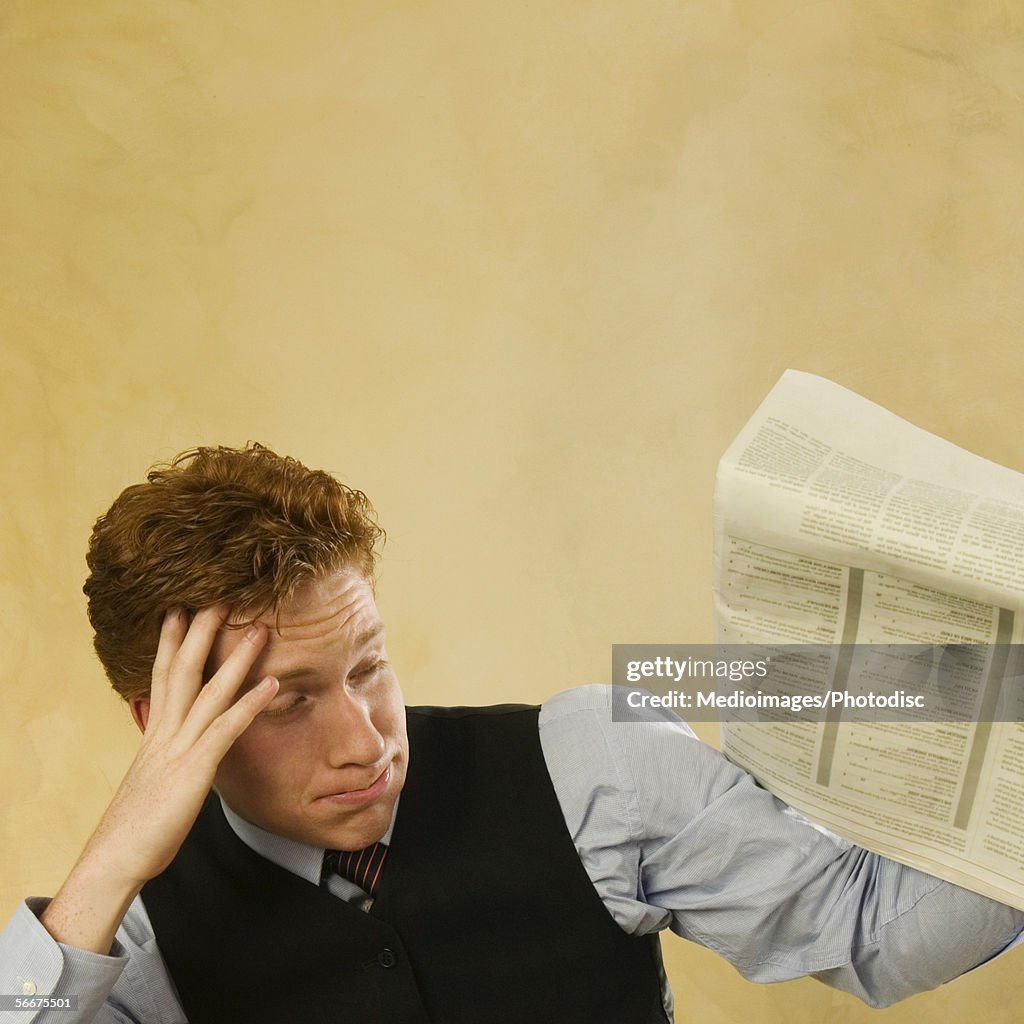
40;569;409;954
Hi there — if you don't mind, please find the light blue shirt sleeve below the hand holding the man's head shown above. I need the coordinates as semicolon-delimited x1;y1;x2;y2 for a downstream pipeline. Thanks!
0;898;187;1024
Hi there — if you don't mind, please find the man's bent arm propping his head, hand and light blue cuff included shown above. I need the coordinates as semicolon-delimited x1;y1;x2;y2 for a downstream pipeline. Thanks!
0;606;278;1024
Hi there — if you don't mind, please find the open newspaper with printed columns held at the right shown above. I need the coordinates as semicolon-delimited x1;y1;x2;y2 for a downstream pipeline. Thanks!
714;371;1024;909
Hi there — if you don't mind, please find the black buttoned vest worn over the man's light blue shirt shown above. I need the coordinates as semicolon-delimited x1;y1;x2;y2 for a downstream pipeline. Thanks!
142;705;666;1024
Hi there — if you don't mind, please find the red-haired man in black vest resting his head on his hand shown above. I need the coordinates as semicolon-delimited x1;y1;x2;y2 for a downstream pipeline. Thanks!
0;445;1024;1024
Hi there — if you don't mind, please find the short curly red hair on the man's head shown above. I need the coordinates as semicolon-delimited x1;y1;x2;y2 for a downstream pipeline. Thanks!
83;442;384;700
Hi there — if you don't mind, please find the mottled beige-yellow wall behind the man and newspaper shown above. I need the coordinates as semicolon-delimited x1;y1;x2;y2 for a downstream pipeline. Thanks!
0;0;1024;1024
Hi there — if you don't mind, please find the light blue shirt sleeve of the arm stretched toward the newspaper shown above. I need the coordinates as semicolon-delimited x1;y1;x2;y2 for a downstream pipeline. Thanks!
541;686;1024;1007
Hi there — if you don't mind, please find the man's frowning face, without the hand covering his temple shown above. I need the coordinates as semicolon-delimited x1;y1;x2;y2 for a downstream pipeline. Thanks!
208;569;409;850
